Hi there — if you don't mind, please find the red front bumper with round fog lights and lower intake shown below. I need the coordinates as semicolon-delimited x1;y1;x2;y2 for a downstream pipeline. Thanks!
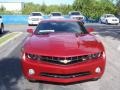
22;58;105;84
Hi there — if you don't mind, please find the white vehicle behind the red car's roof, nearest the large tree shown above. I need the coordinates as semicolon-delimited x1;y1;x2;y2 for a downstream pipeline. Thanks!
68;11;85;24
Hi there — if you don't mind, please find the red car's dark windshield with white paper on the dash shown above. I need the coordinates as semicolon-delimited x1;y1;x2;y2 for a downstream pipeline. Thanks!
35;21;88;34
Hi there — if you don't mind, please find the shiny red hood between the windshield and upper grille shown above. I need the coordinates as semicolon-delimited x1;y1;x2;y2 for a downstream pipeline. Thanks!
25;33;101;56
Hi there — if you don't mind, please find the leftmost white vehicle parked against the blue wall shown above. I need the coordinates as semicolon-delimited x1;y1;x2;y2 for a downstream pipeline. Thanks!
28;12;43;25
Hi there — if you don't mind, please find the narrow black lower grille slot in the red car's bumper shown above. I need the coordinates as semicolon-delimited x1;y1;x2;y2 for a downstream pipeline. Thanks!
40;72;90;79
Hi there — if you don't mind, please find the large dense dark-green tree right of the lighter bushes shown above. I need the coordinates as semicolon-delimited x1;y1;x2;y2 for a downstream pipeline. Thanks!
73;0;116;18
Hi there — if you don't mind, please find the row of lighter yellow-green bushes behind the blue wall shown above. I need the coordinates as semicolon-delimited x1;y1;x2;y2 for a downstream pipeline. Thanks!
22;2;72;14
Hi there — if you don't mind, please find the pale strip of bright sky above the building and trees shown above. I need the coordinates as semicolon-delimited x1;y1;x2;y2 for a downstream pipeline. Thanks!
0;0;74;5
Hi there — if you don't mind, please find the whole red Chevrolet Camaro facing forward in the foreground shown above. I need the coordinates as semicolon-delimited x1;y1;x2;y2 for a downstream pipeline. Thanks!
22;20;106;84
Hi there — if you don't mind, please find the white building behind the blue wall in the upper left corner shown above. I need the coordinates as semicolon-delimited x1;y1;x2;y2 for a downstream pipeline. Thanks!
0;2;24;13
